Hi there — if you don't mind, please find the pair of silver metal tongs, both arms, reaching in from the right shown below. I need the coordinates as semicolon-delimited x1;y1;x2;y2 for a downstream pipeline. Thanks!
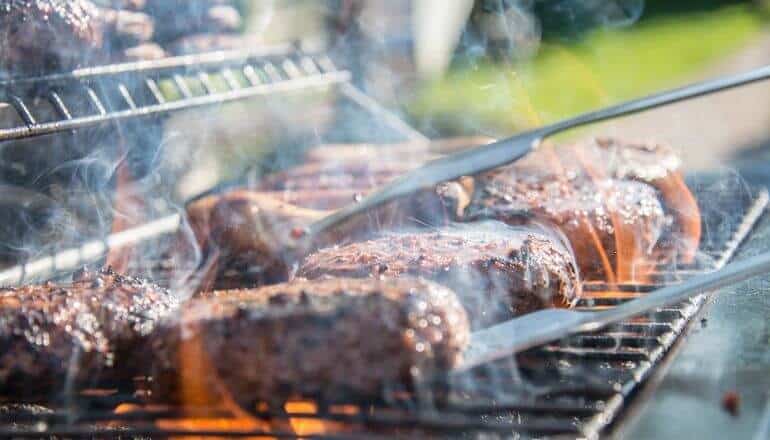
291;66;770;370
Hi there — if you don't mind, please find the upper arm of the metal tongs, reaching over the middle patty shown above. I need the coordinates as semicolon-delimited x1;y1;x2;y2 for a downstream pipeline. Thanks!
288;66;770;255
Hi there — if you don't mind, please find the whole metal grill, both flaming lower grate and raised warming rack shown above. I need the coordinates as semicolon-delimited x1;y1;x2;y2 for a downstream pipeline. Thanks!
0;47;768;438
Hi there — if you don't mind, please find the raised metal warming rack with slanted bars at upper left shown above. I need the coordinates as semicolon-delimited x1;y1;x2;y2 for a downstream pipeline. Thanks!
0;46;352;142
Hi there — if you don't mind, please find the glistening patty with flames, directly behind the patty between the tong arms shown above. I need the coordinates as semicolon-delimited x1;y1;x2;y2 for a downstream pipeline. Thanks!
469;174;666;279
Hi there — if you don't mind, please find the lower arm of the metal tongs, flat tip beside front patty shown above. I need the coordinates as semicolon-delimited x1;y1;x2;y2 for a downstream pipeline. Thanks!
459;252;770;371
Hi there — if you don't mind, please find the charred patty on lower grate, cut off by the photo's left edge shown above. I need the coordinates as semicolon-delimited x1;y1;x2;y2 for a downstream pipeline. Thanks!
0;269;176;399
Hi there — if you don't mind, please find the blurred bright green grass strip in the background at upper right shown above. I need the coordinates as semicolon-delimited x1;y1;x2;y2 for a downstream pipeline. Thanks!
407;1;763;135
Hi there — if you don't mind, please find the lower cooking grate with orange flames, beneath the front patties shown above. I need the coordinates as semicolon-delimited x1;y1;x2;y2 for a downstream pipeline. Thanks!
0;174;767;438
